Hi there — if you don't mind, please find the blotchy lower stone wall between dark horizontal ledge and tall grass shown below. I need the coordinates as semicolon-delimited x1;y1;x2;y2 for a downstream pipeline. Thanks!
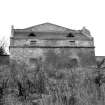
10;47;96;67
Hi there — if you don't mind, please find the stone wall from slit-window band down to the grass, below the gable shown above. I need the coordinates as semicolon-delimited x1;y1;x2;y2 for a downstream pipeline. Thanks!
10;35;96;67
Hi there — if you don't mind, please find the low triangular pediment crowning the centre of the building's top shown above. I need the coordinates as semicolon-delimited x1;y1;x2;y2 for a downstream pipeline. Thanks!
25;23;70;32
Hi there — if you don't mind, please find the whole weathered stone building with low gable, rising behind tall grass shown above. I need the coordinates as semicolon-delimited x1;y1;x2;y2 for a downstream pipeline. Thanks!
10;23;96;69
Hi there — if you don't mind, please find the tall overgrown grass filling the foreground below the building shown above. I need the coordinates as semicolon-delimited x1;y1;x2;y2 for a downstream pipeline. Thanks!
0;61;105;105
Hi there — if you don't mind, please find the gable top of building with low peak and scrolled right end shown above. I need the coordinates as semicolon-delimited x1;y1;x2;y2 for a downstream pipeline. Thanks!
13;22;92;39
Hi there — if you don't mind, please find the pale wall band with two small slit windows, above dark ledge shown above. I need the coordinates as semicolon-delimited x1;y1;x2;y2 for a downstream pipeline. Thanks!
11;38;94;47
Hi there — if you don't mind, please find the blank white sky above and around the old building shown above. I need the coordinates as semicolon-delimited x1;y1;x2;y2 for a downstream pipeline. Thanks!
0;0;105;56
